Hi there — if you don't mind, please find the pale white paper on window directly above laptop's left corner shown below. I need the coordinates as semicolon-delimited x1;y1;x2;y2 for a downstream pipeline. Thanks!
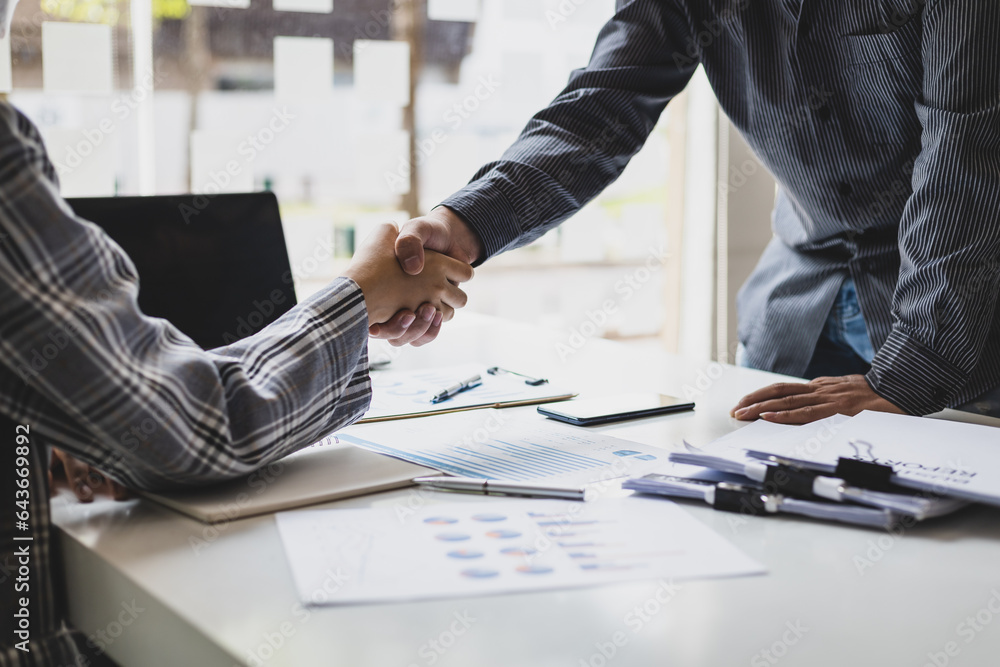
42;128;118;197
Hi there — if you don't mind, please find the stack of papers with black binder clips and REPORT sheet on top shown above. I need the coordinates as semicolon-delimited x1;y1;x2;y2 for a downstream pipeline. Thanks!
624;412;984;527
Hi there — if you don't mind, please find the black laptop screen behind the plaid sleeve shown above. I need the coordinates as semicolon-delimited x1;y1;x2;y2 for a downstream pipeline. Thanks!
67;192;295;349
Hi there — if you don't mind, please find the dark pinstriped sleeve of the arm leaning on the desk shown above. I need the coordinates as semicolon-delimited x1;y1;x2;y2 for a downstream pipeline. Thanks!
868;0;1000;414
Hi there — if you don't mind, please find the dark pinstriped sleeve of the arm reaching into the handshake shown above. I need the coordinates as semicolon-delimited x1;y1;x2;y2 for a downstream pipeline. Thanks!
441;0;697;261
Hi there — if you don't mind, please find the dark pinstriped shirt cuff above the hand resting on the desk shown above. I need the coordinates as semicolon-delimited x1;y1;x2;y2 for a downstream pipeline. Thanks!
866;327;968;415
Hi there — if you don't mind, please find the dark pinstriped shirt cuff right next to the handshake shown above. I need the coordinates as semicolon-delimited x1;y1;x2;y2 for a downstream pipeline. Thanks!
438;178;525;266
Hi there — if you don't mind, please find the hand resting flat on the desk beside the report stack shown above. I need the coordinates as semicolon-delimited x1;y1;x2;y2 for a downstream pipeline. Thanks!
730;375;904;424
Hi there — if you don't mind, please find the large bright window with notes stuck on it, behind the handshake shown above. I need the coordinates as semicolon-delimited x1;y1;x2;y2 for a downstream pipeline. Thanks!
10;0;708;354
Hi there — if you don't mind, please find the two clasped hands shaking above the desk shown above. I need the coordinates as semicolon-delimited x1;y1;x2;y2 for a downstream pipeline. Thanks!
344;206;483;346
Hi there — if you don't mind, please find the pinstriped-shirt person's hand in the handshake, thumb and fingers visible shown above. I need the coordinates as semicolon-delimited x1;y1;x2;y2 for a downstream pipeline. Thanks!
368;206;483;347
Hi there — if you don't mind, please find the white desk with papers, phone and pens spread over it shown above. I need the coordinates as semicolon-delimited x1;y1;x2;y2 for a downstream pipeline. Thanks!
54;315;1000;667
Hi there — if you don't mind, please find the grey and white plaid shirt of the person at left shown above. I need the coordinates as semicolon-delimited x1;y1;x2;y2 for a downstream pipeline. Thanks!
0;103;371;665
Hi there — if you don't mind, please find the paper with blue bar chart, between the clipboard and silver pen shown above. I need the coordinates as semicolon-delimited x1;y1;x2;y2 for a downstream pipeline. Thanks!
338;410;667;485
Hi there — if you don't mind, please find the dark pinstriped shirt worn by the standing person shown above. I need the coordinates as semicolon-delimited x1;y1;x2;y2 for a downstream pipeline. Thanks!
442;0;1000;414
